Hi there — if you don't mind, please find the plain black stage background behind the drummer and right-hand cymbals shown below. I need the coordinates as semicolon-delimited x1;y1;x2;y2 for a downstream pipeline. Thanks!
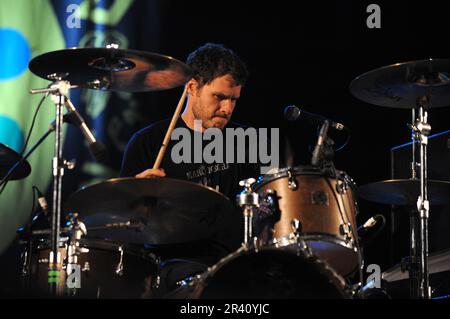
0;0;450;296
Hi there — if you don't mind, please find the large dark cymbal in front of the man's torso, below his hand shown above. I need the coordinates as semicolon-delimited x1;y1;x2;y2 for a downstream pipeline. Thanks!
64;177;240;245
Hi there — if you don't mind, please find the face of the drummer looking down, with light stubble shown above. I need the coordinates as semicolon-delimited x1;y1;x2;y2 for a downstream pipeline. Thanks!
189;75;241;129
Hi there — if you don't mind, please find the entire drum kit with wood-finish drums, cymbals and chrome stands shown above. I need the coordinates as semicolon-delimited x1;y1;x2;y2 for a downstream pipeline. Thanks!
0;45;450;298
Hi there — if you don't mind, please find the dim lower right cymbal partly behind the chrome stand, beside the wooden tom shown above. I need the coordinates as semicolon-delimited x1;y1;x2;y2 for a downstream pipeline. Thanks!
358;179;450;205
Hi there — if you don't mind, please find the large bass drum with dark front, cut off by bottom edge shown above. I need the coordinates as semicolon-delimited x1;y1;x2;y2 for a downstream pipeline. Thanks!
166;247;351;299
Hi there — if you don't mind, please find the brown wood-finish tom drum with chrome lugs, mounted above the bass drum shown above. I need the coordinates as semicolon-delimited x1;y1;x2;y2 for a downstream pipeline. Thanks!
253;167;359;275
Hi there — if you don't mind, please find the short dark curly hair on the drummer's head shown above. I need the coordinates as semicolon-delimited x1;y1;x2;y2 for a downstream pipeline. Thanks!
186;43;248;86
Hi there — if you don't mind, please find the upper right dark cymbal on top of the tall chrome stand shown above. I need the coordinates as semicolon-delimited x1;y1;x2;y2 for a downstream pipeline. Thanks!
350;59;450;109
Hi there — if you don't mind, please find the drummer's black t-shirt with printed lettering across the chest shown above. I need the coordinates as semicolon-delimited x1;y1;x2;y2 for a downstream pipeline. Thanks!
120;117;259;255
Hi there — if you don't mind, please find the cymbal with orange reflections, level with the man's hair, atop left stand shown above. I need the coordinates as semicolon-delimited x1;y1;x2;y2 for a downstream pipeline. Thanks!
29;48;191;92
